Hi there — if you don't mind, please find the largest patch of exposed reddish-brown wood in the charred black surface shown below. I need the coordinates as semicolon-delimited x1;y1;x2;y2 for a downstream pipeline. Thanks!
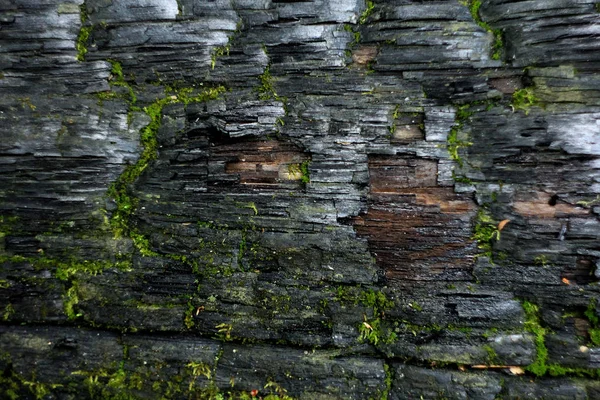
354;156;476;286
